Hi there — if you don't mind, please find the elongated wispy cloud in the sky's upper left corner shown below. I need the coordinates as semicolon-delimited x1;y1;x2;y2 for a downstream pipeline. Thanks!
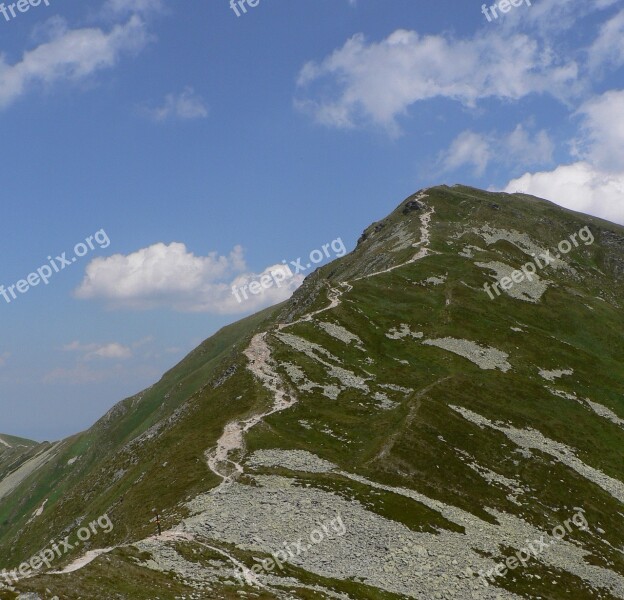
0;15;147;108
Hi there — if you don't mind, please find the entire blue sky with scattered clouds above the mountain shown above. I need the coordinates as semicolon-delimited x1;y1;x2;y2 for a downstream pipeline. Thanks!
0;0;624;440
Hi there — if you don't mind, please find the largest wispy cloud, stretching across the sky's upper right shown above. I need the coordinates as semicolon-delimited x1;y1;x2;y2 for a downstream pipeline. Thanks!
295;0;624;135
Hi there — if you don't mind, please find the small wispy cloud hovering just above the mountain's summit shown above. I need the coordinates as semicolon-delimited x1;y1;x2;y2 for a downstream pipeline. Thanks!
438;125;554;176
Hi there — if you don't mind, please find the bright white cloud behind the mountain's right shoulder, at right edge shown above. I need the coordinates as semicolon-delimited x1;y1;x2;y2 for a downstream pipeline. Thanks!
505;90;624;224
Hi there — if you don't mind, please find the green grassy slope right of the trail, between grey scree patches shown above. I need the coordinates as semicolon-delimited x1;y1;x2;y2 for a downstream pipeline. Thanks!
249;188;624;598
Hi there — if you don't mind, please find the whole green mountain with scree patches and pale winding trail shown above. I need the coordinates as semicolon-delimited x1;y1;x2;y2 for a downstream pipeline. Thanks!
0;186;624;600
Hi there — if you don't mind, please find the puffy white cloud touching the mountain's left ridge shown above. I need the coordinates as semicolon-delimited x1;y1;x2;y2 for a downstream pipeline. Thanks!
75;242;303;314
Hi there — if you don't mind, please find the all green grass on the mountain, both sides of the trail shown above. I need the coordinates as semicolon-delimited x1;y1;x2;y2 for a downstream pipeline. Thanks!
0;186;624;600
